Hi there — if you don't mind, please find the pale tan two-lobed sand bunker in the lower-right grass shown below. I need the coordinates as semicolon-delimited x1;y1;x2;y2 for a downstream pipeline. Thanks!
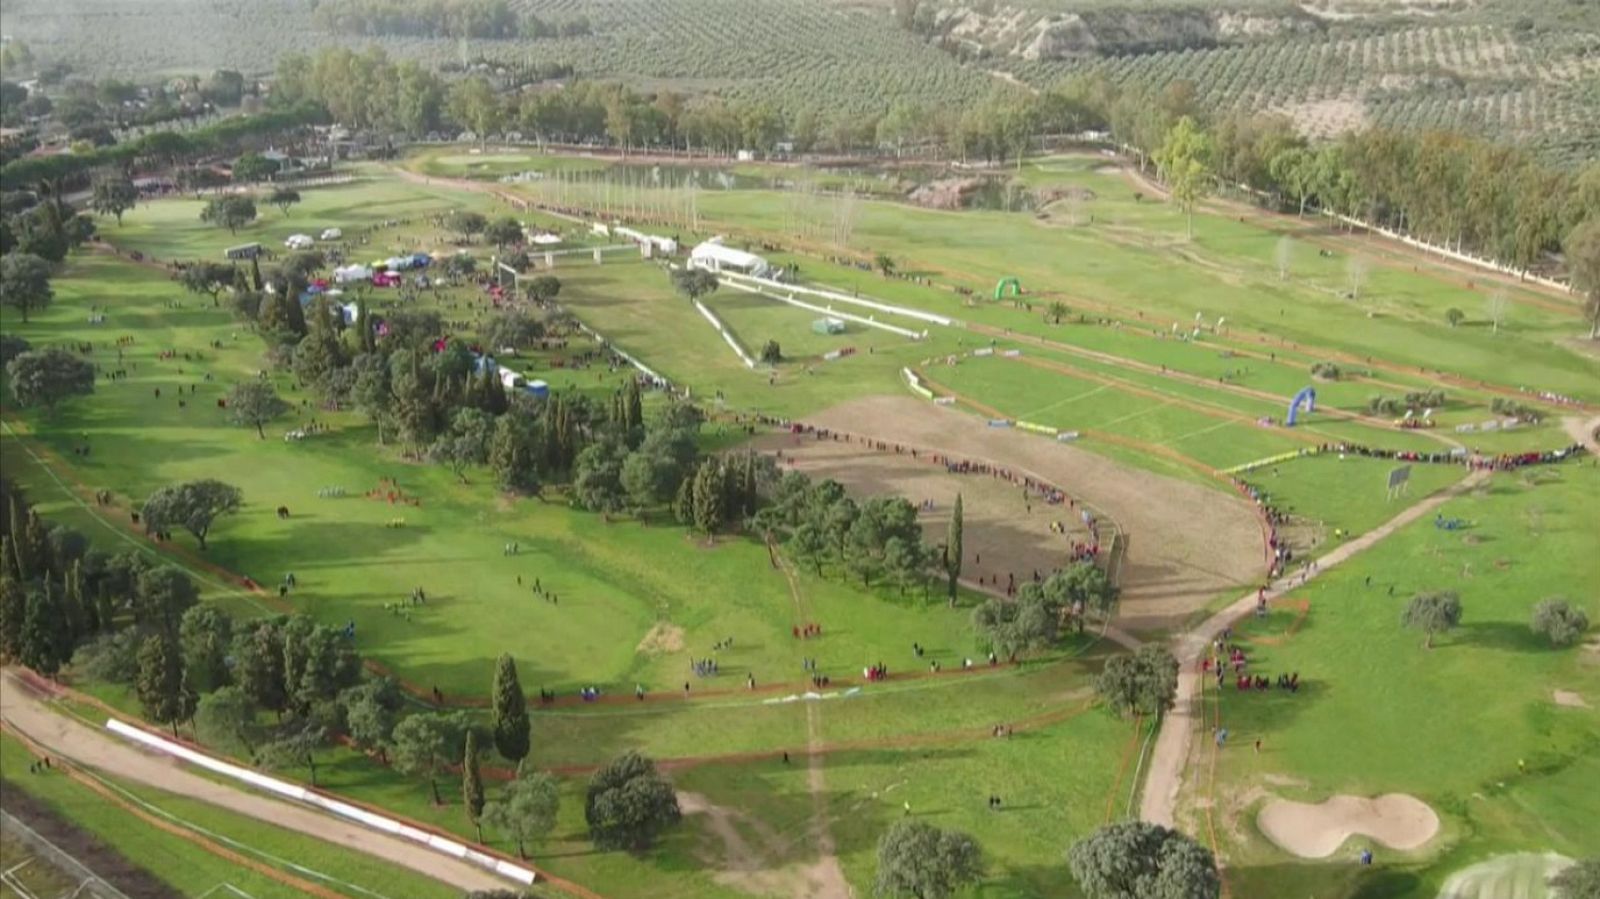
1256;793;1438;859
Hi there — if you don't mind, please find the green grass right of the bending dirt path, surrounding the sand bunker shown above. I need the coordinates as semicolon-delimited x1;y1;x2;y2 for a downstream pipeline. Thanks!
1216;461;1600;899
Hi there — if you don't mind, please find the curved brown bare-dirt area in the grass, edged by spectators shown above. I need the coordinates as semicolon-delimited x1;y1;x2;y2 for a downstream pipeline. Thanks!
763;397;1264;630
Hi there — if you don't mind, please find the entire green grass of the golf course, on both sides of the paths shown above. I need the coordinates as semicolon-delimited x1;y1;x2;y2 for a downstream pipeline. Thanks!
0;157;1600;899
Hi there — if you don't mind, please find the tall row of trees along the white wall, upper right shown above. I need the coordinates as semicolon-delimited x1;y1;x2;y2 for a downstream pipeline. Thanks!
1075;77;1600;319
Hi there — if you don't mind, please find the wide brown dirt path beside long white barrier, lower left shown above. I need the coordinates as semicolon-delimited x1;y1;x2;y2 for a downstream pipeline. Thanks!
0;670;524;891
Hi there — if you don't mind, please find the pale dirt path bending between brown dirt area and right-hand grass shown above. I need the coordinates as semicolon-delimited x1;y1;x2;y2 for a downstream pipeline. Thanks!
1139;470;1490;827
